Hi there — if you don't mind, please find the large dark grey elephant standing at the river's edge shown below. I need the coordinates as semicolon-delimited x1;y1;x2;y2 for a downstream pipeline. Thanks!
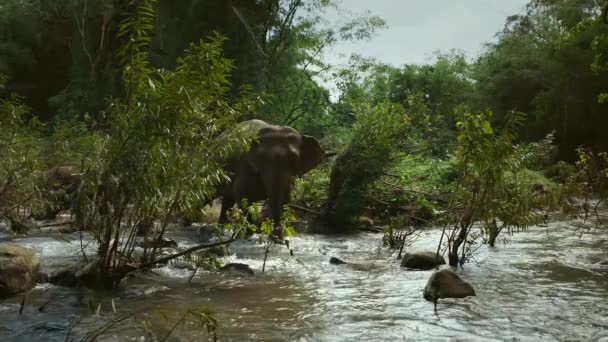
219;120;332;239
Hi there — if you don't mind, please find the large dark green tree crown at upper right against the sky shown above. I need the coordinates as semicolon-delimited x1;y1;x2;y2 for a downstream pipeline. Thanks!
472;0;608;161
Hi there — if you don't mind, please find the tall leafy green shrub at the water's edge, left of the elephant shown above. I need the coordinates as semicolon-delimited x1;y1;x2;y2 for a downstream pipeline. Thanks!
71;1;252;286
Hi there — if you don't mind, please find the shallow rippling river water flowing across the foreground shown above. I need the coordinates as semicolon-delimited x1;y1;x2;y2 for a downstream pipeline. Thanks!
0;222;608;342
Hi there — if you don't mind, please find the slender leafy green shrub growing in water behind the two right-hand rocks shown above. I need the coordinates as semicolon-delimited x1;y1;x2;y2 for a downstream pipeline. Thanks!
442;112;546;266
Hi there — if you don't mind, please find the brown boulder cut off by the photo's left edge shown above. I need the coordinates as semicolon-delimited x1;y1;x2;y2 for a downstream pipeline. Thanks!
0;243;40;298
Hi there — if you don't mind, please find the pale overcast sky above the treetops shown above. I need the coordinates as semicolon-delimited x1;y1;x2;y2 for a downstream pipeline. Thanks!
324;0;528;66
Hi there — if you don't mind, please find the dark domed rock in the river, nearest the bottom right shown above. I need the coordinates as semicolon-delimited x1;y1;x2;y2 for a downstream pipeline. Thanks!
424;269;475;302
